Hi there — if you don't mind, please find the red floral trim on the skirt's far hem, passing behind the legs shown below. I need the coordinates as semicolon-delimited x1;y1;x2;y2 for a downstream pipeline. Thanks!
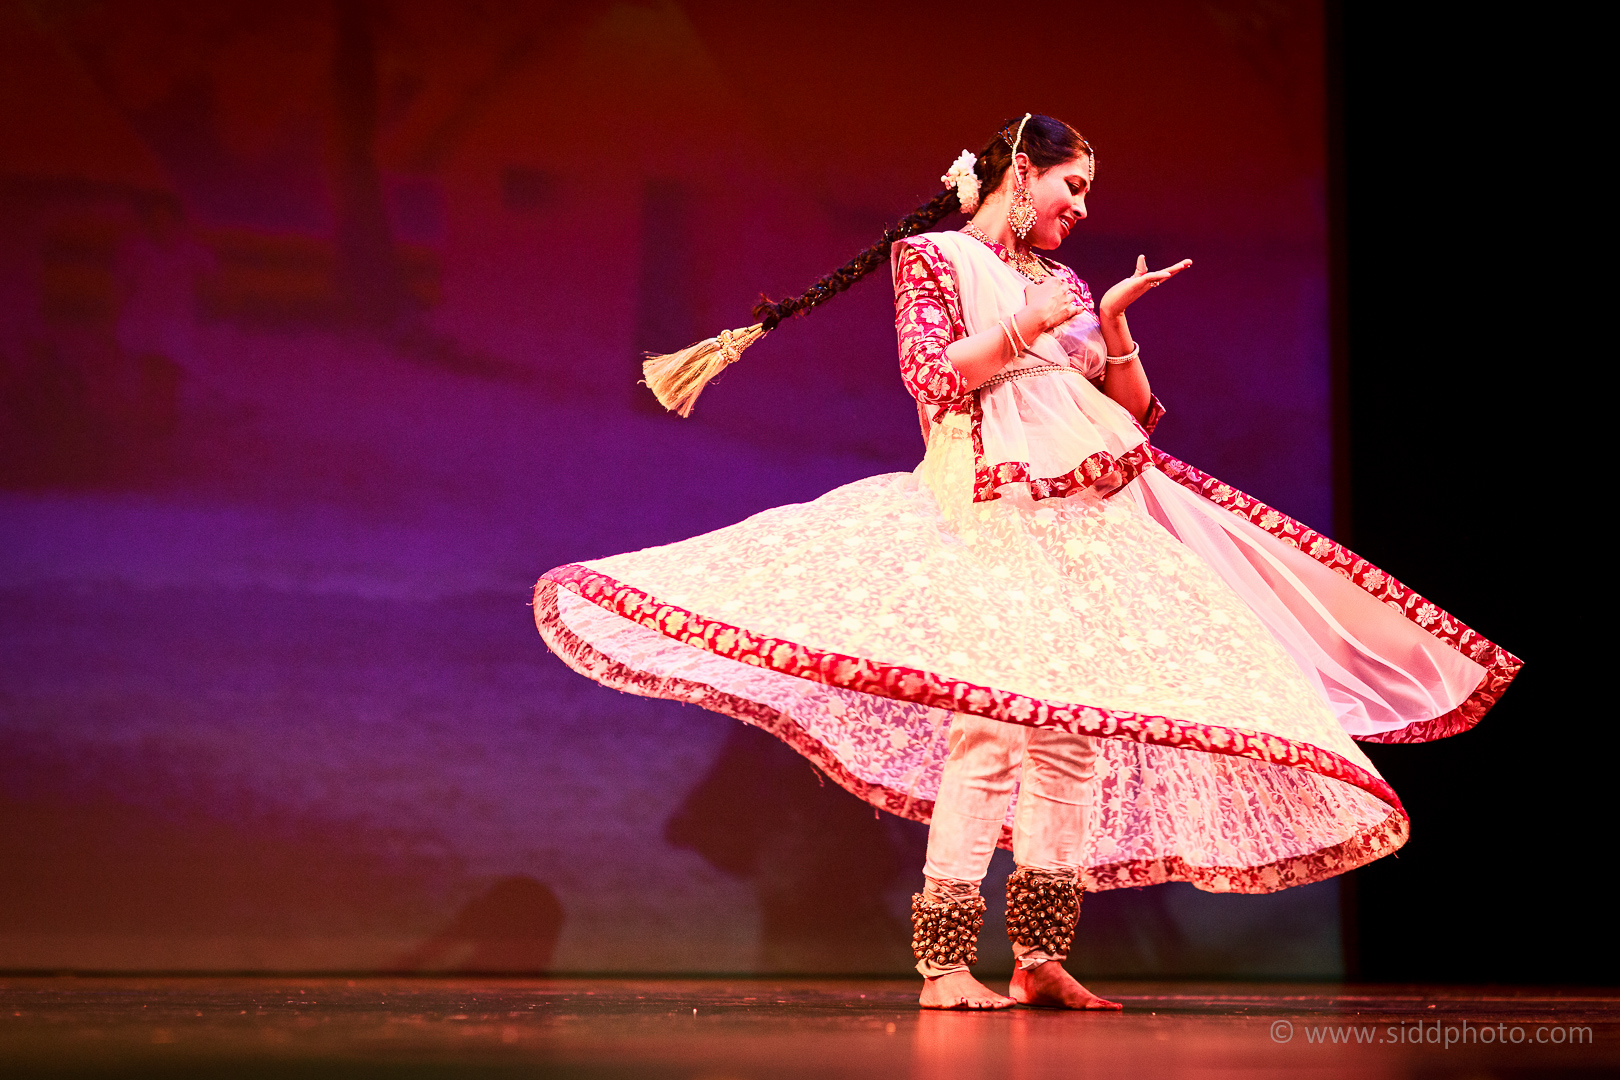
535;582;1409;892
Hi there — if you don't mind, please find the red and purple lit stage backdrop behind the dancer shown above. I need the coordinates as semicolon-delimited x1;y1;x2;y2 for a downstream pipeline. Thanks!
0;0;1340;975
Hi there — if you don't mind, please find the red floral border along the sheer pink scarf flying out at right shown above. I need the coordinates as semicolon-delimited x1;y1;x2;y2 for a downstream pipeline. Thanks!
1153;449;1524;743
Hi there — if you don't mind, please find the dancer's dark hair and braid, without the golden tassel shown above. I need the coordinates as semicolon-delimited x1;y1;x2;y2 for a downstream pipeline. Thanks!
753;117;1092;330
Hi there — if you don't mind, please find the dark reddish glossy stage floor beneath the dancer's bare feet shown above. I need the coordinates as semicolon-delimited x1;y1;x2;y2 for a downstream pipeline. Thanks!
0;976;1620;1080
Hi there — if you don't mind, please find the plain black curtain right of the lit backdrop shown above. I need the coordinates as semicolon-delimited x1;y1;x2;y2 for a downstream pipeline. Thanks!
1328;3;1617;984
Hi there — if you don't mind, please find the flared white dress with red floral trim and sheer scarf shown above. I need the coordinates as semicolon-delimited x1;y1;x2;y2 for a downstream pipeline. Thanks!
535;233;1520;892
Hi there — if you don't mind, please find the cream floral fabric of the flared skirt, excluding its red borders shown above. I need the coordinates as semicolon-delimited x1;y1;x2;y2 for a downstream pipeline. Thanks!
538;418;1406;892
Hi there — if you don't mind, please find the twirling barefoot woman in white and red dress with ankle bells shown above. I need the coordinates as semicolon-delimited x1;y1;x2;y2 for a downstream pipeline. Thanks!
535;115;1520;1009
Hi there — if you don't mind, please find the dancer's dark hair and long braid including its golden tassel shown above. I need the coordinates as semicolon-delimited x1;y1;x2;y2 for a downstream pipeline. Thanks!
642;117;1092;416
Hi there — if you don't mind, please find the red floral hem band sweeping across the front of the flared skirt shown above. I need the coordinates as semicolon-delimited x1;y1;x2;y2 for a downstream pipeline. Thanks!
541;563;1401;808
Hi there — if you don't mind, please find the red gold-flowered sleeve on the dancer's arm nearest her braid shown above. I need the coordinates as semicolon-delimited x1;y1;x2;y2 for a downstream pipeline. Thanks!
894;240;967;405
